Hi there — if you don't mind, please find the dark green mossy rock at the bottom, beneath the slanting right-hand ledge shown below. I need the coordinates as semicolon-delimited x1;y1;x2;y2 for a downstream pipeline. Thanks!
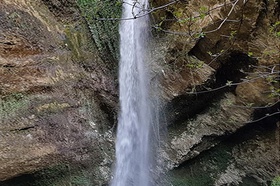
171;144;232;186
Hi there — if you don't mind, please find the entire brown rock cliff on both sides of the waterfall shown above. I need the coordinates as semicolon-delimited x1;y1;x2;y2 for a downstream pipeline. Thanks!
0;0;280;186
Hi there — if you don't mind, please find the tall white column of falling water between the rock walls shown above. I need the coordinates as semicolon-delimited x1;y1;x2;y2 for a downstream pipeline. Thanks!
111;0;152;186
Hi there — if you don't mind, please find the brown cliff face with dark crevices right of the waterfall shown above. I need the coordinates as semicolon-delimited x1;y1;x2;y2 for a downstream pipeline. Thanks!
152;0;280;185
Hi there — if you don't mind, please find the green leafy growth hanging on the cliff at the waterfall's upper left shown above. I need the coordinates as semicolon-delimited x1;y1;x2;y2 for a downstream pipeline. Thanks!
78;0;122;63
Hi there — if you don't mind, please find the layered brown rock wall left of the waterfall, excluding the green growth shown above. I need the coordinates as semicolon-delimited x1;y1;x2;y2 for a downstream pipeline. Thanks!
0;0;118;185
